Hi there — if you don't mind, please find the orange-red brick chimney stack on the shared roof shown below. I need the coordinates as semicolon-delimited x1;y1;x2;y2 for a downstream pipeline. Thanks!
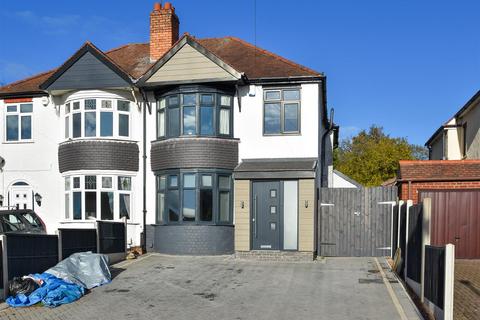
150;2;180;61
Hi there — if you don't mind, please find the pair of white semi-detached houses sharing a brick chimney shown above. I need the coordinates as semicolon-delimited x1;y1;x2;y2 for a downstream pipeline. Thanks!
0;3;338;255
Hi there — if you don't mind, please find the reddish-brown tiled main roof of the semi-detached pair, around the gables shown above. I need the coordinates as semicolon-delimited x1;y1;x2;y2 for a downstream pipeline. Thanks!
0;37;323;96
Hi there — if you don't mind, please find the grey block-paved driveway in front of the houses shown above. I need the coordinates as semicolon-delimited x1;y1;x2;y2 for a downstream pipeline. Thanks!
0;254;421;320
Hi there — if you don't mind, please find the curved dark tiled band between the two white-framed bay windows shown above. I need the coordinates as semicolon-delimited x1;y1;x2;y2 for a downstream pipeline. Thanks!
58;140;139;172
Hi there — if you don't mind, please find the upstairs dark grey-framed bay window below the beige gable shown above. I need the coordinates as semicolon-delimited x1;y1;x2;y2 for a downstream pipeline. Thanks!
157;92;233;139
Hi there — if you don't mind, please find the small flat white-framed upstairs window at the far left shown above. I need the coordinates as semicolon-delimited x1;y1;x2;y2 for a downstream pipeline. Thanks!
5;103;33;142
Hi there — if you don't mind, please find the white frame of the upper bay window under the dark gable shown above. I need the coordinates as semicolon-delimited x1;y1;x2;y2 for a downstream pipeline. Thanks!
63;98;132;140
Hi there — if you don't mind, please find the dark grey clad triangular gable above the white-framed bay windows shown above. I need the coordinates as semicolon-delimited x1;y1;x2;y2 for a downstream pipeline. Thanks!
48;52;129;90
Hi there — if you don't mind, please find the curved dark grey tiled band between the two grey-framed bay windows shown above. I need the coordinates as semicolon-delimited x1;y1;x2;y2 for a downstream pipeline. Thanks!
151;138;238;171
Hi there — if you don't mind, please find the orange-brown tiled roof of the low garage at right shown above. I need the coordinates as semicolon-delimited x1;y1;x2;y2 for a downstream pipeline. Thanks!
397;160;480;181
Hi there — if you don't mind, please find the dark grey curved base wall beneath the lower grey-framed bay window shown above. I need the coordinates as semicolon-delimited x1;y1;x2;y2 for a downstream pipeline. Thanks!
146;225;234;255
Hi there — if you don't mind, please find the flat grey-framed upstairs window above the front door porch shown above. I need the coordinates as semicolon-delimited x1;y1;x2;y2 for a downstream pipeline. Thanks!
263;88;300;135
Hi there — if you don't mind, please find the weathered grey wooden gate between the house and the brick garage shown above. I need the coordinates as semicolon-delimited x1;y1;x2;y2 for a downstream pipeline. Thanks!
318;187;397;257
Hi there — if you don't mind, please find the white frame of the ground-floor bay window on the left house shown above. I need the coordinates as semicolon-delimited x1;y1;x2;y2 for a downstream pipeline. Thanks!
62;173;134;222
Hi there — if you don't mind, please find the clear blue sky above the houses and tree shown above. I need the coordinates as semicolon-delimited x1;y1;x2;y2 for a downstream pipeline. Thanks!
0;0;480;145
